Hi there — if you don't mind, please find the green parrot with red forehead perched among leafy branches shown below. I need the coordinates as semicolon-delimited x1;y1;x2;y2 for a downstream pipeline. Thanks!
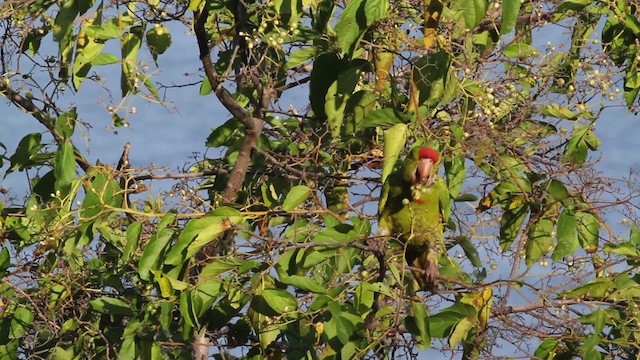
378;147;450;290
